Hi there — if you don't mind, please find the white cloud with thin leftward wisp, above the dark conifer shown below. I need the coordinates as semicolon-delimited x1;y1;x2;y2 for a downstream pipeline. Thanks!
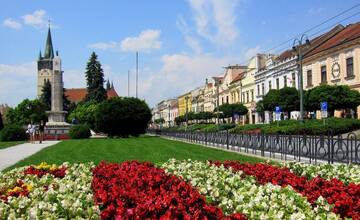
89;29;162;52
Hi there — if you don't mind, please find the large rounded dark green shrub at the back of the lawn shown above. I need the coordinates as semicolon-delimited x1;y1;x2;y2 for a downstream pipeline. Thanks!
95;97;151;137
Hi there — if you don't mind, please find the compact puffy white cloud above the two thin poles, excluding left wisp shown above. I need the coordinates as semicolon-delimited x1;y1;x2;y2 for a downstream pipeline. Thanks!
120;29;162;51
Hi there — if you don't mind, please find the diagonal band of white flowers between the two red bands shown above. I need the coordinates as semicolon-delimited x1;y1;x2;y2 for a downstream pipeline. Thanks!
161;159;337;219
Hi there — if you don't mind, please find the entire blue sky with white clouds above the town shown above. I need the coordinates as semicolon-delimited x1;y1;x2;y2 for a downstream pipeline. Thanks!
0;0;360;106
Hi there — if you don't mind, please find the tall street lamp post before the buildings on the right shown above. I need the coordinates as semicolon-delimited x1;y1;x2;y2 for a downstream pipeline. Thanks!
293;34;310;122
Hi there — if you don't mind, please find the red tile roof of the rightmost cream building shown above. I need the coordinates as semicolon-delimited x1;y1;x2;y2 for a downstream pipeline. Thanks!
307;22;360;57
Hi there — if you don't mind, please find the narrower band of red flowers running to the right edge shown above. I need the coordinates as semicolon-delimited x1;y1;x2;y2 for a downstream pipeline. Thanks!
214;161;360;218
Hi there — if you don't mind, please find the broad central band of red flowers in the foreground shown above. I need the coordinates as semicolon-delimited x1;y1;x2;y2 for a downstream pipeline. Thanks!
92;161;245;219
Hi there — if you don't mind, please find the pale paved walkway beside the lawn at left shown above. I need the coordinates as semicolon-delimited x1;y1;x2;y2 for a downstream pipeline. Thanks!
0;141;60;171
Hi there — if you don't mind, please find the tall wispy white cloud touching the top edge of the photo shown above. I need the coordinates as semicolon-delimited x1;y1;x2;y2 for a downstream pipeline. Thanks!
189;0;239;46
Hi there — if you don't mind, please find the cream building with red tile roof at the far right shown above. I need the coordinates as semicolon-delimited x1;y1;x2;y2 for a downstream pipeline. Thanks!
303;23;360;117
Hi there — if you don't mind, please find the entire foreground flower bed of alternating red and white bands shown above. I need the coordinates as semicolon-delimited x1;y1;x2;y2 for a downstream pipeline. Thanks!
0;159;360;219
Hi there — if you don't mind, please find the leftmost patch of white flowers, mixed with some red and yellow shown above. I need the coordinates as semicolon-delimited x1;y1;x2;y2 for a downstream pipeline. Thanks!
0;163;99;219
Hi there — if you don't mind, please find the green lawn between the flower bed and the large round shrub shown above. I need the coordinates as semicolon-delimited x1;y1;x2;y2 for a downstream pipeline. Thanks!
8;136;261;167
